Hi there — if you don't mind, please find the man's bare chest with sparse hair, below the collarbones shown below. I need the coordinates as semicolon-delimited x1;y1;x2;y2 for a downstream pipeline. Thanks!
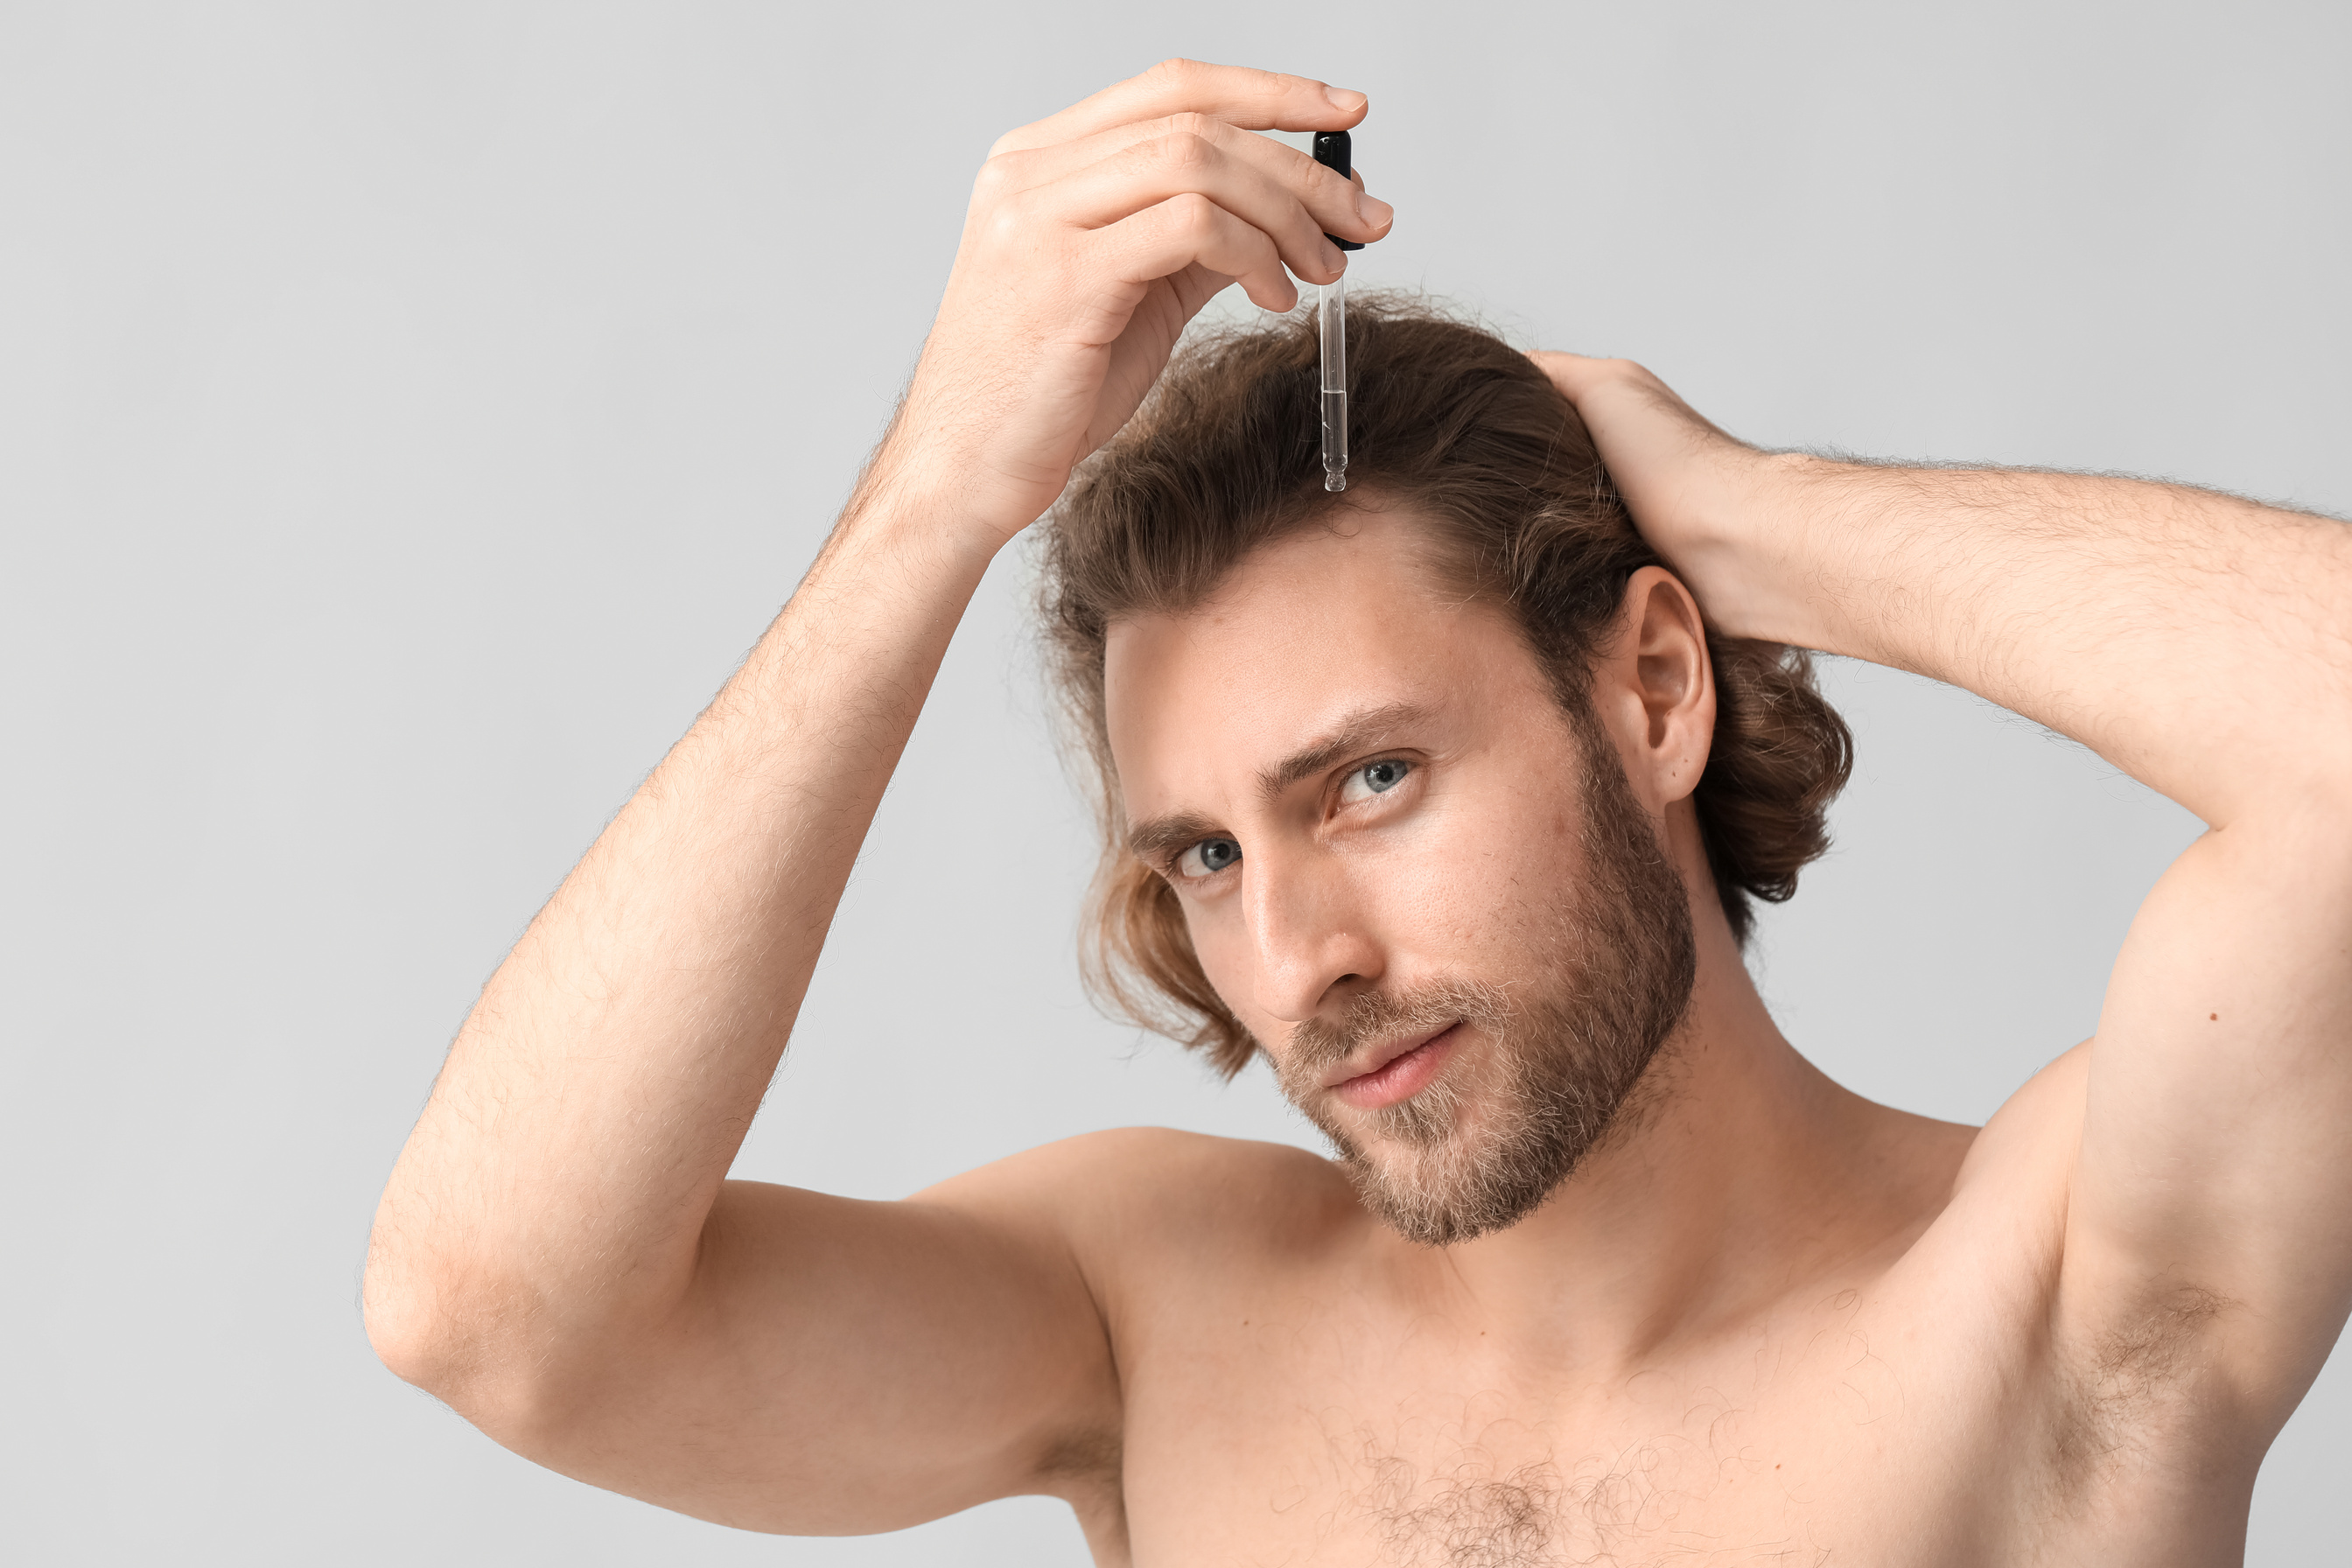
1100;1302;2041;1568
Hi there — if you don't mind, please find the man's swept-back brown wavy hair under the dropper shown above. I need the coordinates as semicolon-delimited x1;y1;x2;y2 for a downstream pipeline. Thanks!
1040;297;1853;1076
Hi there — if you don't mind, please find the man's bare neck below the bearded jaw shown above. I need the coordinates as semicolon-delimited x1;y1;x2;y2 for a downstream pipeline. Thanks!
1442;877;1969;1366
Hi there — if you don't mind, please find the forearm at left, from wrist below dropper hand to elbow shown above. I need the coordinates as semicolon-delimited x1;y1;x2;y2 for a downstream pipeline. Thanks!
369;463;990;1359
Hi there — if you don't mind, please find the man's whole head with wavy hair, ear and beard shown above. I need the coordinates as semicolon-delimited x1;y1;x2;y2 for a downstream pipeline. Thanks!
1046;301;1846;1242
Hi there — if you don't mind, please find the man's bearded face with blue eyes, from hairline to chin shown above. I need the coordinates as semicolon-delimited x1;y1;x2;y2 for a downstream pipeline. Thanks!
1105;510;1693;1243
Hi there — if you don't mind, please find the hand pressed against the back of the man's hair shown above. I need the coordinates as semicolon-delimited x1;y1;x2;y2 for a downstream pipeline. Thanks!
1529;350;1802;637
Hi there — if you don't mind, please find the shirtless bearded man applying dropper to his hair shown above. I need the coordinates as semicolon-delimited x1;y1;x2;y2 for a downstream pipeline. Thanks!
367;61;2352;1565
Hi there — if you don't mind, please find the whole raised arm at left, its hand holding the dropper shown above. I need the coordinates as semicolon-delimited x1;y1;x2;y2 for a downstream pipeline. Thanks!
367;61;1385;1533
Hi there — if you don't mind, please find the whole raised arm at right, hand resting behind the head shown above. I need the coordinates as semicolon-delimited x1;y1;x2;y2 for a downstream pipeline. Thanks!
1538;355;2352;1438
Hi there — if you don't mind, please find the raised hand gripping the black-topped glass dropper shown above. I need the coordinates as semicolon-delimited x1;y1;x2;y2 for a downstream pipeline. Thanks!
878;61;1390;548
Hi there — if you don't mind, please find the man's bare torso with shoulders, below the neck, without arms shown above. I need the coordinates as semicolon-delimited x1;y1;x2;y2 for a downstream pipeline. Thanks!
1066;1054;2267;1568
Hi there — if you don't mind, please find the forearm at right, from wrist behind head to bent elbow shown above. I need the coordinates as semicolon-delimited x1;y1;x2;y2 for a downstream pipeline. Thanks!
1691;456;2352;825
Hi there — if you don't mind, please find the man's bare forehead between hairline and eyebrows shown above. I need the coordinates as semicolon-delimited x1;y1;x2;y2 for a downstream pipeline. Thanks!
1103;508;1550;818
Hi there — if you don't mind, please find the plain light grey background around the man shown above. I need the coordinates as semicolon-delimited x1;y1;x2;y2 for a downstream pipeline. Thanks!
0;0;2352;1565
